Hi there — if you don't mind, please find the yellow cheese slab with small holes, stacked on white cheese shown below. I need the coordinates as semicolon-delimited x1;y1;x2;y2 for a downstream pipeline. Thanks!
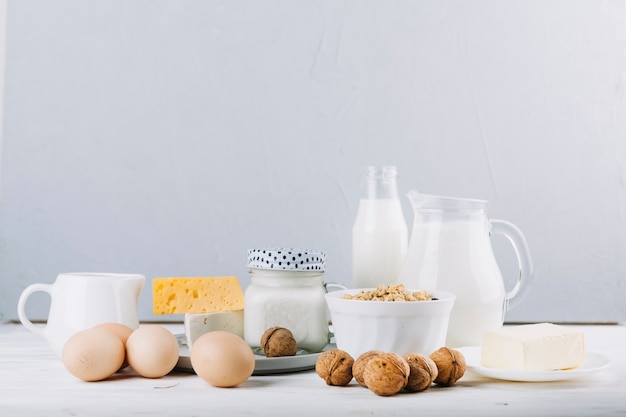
152;276;243;314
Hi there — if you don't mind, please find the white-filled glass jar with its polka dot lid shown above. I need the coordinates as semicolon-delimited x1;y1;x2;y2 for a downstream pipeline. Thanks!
243;248;329;352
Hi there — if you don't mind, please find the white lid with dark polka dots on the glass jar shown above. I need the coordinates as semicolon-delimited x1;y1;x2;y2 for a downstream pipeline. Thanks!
248;248;326;271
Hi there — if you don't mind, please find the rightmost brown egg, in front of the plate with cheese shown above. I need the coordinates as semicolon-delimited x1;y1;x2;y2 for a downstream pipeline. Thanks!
189;330;255;387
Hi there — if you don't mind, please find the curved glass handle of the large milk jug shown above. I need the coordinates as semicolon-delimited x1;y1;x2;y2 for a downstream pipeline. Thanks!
490;220;533;311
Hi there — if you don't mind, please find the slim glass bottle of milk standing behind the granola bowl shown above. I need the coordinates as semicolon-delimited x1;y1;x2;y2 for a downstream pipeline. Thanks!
352;166;408;288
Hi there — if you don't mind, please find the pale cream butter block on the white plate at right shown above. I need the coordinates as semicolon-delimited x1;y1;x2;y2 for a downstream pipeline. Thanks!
480;323;585;371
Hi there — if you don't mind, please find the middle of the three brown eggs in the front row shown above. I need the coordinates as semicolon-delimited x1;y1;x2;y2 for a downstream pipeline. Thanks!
126;324;179;378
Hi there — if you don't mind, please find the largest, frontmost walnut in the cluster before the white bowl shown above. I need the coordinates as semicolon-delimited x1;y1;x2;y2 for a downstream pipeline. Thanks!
363;353;411;396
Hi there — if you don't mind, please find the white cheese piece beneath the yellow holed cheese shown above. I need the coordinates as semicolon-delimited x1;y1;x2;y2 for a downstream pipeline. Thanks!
185;310;243;349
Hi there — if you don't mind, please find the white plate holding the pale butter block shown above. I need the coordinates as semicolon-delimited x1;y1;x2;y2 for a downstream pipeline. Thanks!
458;346;611;382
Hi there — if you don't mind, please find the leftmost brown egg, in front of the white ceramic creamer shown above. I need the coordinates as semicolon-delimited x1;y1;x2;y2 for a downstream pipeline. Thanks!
61;327;124;381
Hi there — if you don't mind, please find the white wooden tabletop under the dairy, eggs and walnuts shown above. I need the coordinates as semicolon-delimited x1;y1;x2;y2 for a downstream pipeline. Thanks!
0;323;626;417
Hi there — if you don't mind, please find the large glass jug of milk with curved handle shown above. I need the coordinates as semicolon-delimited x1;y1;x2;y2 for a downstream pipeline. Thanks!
398;190;532;347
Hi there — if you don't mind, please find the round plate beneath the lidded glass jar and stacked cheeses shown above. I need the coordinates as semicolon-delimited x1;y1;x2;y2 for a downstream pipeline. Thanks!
176;334;335;375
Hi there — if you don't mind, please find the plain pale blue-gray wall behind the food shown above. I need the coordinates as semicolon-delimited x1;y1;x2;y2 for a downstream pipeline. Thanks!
0;0;626;322
